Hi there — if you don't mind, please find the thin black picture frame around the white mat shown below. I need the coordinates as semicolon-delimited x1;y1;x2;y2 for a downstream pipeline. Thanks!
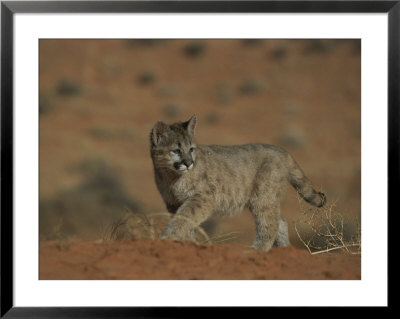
0;0;394;318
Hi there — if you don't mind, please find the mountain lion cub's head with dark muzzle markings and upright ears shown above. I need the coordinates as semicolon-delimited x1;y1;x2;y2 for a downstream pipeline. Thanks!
150;115;197;175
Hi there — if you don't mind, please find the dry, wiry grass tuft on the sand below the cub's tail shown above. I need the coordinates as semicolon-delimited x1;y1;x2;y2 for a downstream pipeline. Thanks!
295;198;361;255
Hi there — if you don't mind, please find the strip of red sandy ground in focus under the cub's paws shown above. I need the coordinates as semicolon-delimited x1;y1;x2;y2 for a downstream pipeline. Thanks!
40;240;361;280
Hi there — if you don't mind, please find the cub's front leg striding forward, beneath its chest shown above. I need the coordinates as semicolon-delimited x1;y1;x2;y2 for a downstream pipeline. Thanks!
161;196;213;240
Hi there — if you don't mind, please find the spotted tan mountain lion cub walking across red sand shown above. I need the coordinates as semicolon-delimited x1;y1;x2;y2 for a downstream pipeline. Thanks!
150;116;326;251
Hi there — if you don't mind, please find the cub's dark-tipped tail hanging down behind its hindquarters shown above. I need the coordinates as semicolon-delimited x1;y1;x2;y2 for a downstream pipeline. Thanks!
288;155;326;207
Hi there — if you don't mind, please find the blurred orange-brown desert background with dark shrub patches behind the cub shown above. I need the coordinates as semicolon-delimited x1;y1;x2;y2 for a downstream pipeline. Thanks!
39;39;361;245
